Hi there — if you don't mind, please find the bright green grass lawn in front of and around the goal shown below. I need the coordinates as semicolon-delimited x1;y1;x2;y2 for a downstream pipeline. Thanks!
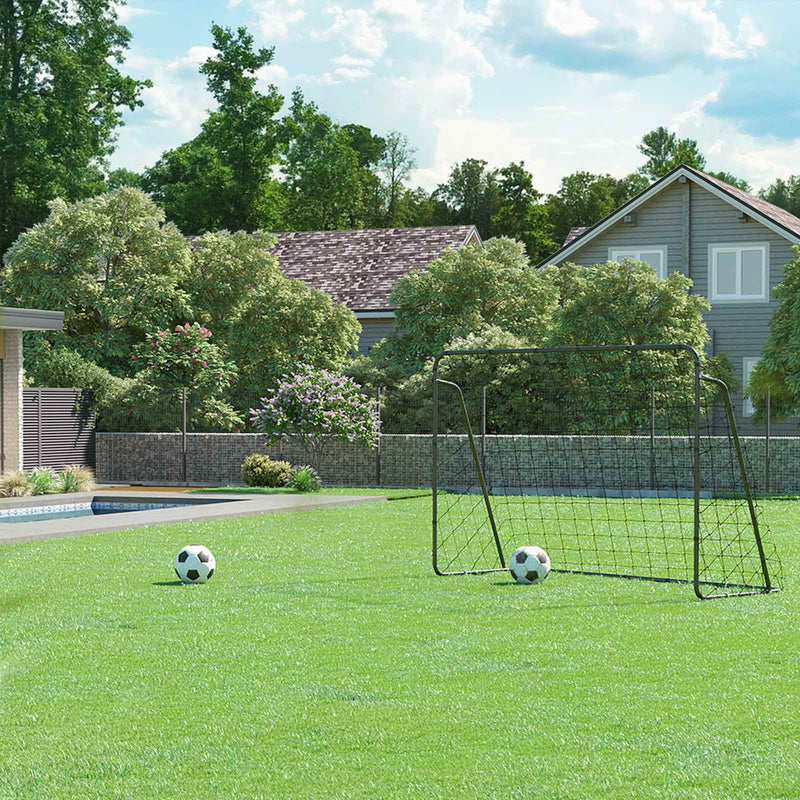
0;498;800;800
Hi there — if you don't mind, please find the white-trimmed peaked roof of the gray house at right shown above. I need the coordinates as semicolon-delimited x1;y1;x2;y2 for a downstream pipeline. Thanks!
537;164;800;268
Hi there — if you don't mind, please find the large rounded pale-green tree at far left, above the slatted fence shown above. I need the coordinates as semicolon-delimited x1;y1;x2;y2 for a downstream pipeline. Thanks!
2;188;190;376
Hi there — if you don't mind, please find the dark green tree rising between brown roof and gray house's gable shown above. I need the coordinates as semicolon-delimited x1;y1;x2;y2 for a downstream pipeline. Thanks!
492;161;558;264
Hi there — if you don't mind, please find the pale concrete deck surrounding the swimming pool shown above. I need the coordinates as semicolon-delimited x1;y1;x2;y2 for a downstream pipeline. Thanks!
0;491;386;545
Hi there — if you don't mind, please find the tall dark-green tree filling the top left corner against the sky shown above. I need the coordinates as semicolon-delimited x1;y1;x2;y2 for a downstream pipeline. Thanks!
0;0;150;254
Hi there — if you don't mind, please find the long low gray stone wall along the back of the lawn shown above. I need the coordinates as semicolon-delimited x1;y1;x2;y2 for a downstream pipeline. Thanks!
96;433;800;493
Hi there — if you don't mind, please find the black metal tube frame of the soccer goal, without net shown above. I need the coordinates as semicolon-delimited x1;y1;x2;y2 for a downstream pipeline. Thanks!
431;344;778;600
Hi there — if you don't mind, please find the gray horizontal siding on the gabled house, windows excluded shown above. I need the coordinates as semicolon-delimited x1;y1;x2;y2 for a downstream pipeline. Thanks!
565;180;798;436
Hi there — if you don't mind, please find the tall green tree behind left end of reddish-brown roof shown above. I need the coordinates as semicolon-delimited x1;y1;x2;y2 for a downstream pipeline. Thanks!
282;89;368;231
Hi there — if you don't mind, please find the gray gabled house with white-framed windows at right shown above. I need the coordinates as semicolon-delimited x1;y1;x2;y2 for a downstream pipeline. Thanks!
538;166;800;434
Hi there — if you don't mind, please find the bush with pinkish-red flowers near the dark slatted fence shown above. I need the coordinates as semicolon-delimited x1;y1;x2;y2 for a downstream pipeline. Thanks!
126;322;243;430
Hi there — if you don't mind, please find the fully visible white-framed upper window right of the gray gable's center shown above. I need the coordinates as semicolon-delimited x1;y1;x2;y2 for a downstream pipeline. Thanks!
708;243;769;302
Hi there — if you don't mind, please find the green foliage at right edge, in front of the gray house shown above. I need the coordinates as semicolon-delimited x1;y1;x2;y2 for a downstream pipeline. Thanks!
747;247;800;424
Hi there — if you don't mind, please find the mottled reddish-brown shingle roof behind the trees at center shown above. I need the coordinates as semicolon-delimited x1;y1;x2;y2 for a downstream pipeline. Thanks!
272;225;480;312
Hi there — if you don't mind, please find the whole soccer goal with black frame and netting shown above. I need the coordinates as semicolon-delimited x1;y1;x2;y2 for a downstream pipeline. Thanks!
432;345;780;599
